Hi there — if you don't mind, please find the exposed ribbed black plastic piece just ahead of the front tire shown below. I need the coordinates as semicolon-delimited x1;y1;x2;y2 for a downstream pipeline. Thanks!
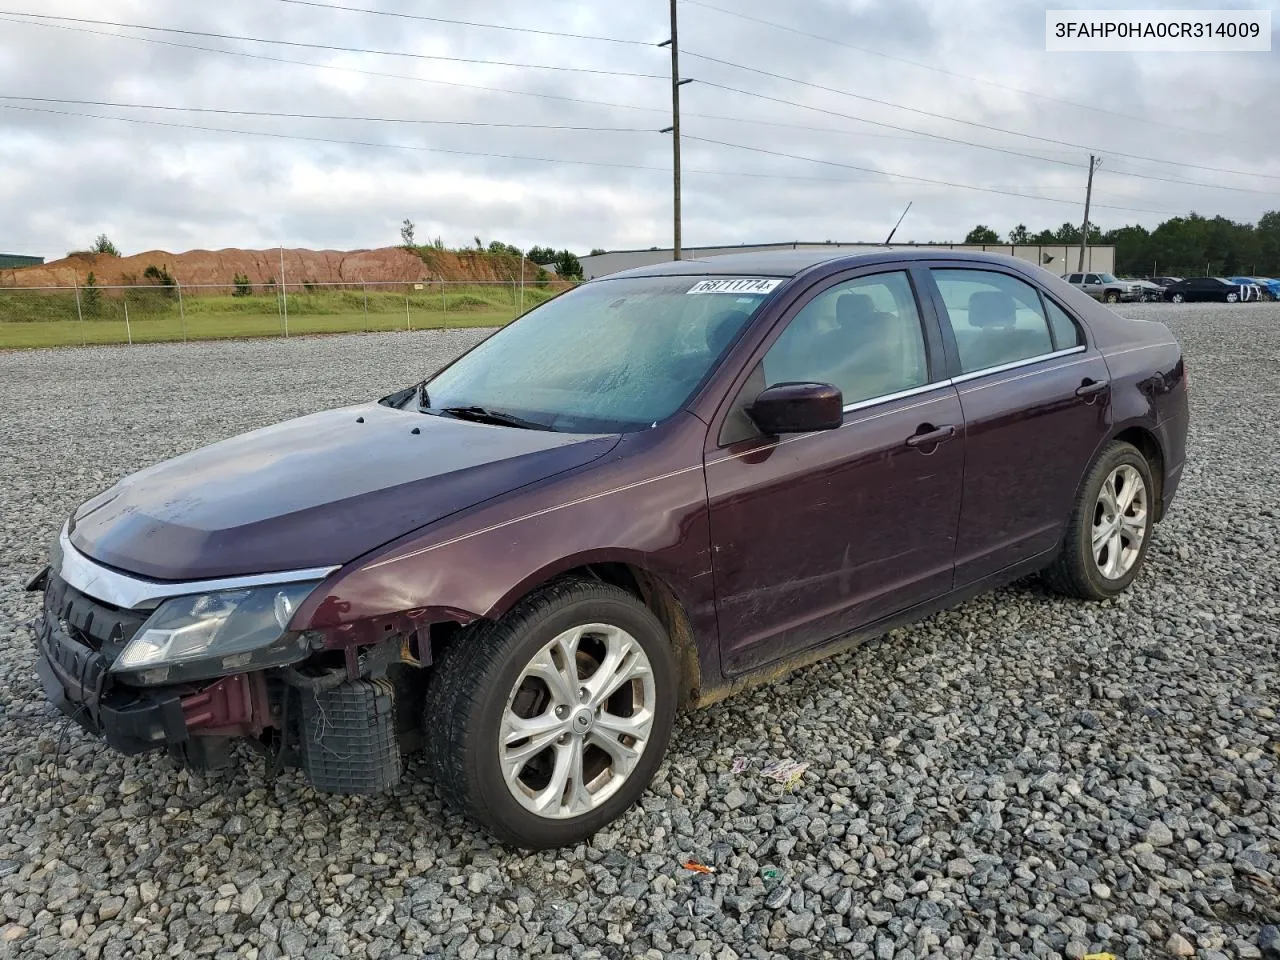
297;680;401;794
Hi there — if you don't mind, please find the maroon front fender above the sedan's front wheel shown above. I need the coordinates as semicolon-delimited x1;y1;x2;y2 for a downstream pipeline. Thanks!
291;415;718;686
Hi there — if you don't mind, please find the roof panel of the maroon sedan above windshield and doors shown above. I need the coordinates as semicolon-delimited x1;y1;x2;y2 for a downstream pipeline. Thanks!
593;247;1034;283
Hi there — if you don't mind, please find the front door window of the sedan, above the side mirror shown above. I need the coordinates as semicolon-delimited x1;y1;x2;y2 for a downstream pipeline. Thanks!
763;271;929;403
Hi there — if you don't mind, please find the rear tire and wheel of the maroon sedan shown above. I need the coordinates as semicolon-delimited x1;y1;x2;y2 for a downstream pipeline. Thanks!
1043;442;1156;600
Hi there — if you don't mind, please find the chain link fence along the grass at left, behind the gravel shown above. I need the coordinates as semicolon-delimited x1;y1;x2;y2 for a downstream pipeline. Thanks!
0;279;575;349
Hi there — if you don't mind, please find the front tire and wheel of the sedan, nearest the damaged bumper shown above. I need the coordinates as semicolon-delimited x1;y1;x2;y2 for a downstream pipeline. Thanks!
424;580;678;850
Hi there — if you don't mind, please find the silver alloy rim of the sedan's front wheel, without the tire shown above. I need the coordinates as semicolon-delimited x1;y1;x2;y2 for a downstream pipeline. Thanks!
498;623;657;819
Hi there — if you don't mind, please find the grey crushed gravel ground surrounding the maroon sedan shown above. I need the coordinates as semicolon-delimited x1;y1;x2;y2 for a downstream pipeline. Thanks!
0;305;1280;960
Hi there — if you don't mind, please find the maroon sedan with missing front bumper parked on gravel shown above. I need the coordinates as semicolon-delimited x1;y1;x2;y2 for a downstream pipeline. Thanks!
32;251;1187;847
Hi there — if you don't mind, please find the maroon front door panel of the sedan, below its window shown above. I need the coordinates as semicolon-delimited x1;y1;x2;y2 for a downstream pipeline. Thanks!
707;384;964;675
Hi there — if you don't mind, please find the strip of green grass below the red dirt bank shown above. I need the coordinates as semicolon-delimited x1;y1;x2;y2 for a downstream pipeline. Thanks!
0;285;570;349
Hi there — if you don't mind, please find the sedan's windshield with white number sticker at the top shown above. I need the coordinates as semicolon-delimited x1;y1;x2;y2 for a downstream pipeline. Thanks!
425;276;785;433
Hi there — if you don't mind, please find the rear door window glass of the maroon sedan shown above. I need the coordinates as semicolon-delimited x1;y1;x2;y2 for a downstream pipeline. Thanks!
932;269;1054;374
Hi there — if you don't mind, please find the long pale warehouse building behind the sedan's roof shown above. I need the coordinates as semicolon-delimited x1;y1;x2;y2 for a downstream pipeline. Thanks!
581;242;1116;280
